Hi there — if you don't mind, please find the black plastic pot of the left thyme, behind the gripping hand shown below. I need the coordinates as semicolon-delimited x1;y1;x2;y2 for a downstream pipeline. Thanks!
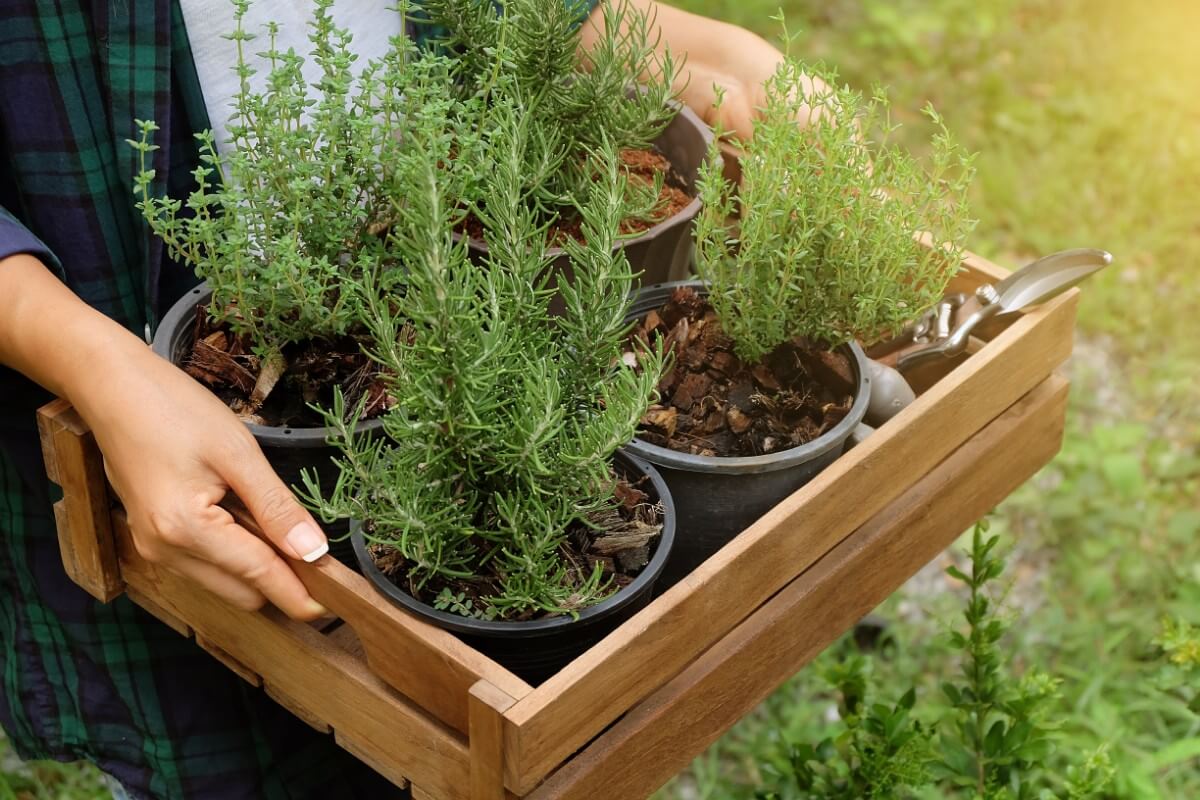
151;283;383;565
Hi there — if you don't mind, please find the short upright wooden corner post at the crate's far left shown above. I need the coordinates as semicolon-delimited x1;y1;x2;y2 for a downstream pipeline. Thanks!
37;399;125;603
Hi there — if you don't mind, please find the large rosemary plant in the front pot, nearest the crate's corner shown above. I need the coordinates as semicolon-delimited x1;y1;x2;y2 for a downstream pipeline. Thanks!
305;101;662;619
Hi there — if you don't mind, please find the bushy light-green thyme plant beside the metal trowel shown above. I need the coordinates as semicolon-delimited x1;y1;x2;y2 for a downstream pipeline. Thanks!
696;58;973;361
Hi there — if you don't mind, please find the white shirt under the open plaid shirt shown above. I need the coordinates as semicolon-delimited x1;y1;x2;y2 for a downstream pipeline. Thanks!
180;0;401;156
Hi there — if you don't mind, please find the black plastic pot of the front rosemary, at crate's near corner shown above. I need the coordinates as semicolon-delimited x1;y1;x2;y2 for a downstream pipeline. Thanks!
350;452;676;686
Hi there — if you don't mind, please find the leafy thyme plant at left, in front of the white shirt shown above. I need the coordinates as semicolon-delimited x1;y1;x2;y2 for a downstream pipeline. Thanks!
131;0;451;359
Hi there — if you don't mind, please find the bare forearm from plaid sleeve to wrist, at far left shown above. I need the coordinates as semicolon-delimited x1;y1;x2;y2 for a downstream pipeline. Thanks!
0;254;150;412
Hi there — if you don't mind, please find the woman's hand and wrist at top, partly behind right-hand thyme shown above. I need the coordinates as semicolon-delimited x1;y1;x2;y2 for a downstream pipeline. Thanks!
580;0;814;140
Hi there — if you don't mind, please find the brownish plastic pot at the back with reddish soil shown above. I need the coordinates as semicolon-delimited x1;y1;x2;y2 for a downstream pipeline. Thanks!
460;103;713;298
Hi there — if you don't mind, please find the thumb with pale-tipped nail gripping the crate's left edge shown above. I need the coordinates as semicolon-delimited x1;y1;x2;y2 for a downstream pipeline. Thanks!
214;447;329;561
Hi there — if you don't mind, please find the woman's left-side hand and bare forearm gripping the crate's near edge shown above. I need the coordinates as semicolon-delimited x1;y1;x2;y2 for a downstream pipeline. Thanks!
0;255;329;620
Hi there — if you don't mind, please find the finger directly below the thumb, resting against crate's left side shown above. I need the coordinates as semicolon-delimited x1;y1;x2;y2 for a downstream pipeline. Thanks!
185;522;329;621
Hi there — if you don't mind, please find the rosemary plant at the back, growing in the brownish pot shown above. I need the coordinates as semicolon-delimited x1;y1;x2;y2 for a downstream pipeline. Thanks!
416;0;679;237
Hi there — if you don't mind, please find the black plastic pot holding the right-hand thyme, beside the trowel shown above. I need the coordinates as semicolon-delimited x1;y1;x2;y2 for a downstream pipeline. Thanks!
626;281;871;590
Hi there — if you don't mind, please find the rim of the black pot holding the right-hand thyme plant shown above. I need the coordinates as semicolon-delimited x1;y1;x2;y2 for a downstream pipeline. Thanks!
625;278;871;475
